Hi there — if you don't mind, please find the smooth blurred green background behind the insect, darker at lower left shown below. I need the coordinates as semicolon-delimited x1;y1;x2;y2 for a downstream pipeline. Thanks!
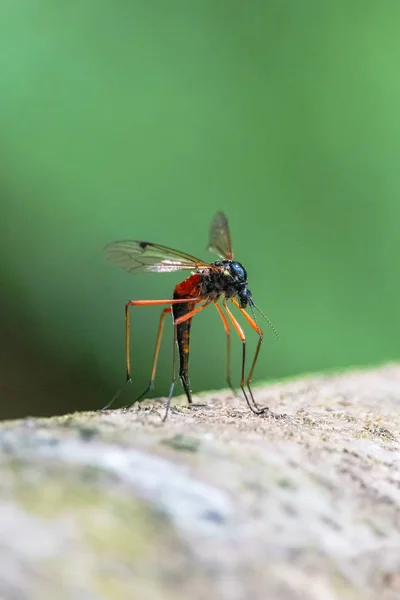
0;0;400;417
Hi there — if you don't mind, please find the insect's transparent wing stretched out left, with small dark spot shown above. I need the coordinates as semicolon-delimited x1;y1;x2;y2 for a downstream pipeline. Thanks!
104;240;210;273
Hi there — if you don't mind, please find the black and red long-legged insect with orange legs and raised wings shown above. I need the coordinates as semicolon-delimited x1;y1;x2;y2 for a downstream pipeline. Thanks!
103;212;280;421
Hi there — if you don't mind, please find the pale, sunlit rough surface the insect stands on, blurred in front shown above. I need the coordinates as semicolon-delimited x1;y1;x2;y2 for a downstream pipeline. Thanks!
0;365;400;600
